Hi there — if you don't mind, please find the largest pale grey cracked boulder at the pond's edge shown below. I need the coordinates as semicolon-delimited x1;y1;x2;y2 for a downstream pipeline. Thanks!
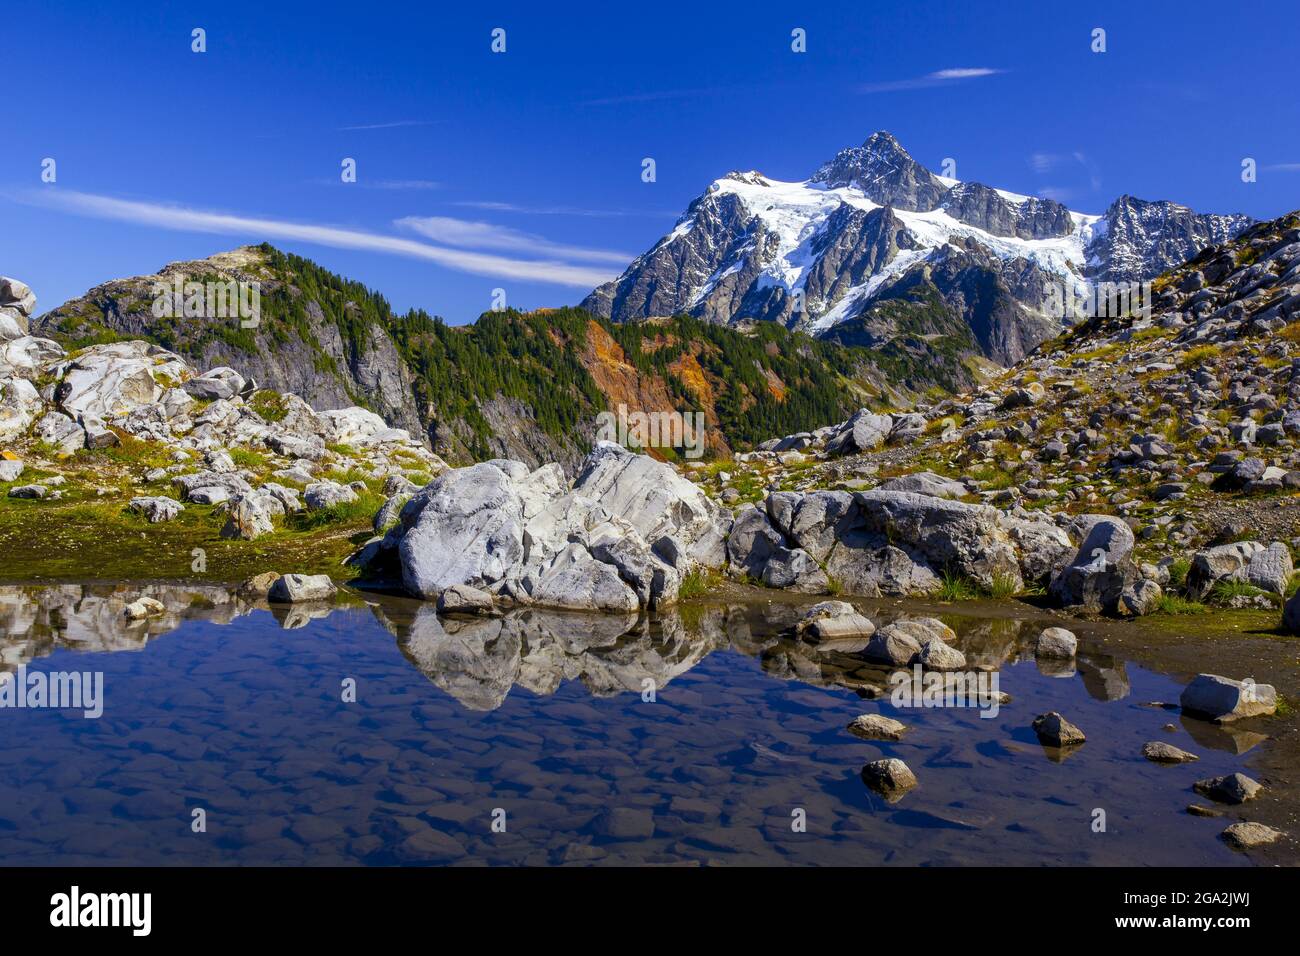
385;442;732;611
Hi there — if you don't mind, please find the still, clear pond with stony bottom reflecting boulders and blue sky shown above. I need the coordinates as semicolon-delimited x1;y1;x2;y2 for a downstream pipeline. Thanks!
0;587;1257;865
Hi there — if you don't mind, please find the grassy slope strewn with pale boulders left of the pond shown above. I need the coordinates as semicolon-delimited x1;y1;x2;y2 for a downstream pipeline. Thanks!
0;278;446;561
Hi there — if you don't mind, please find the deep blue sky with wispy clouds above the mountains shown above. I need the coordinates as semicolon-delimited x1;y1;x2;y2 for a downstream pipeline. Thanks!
0;0;1300;323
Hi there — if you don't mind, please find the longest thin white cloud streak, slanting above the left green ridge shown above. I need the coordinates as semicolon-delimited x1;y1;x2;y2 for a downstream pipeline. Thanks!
8;187;614;289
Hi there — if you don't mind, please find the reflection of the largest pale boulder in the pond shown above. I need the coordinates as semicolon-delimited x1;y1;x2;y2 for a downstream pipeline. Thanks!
381;606;723;710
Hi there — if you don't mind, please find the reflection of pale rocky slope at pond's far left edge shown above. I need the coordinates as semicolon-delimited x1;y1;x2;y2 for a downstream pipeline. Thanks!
0;584;251;671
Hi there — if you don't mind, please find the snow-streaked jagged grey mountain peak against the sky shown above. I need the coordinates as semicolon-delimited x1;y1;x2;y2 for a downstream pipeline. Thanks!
582;131;1251;364
